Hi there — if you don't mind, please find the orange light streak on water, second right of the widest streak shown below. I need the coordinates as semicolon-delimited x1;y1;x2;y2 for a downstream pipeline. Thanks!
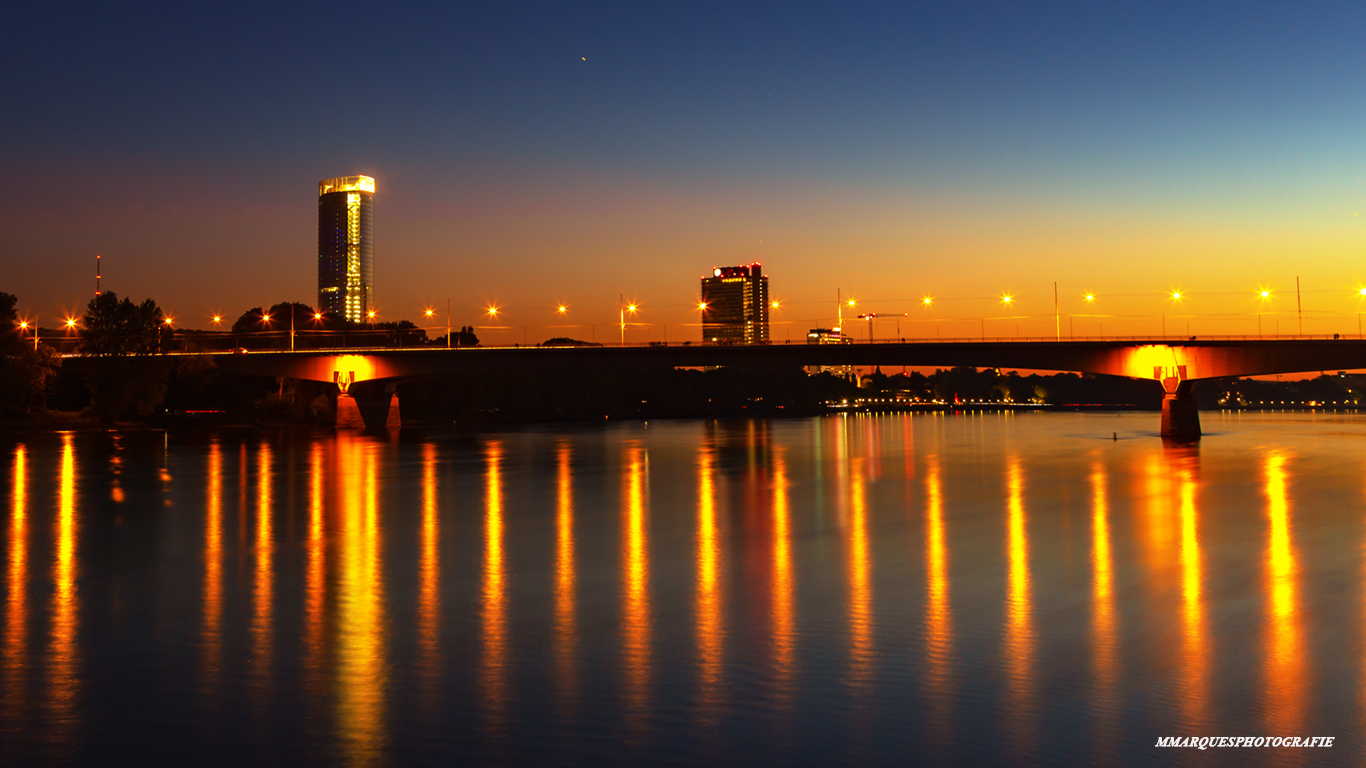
482;440;507;730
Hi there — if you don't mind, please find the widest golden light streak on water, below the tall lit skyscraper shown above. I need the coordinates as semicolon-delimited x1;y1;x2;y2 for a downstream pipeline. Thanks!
336;439;388;765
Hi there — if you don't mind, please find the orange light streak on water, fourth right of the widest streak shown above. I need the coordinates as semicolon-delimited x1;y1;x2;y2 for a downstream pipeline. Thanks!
622;443;652;730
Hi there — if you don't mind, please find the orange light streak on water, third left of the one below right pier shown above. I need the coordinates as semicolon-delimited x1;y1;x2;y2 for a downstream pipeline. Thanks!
925;456;953;735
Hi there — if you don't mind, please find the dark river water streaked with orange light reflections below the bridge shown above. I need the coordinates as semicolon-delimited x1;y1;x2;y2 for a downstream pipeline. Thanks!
0;414;1366;765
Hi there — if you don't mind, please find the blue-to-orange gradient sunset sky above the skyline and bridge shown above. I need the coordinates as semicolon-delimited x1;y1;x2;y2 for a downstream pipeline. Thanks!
0;1;1366;342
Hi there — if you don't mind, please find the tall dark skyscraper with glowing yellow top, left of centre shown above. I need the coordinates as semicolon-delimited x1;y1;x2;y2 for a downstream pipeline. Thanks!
318;176;374;323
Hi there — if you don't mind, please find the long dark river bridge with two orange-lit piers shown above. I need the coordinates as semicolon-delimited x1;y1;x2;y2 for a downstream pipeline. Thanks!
184;338;1366;440
